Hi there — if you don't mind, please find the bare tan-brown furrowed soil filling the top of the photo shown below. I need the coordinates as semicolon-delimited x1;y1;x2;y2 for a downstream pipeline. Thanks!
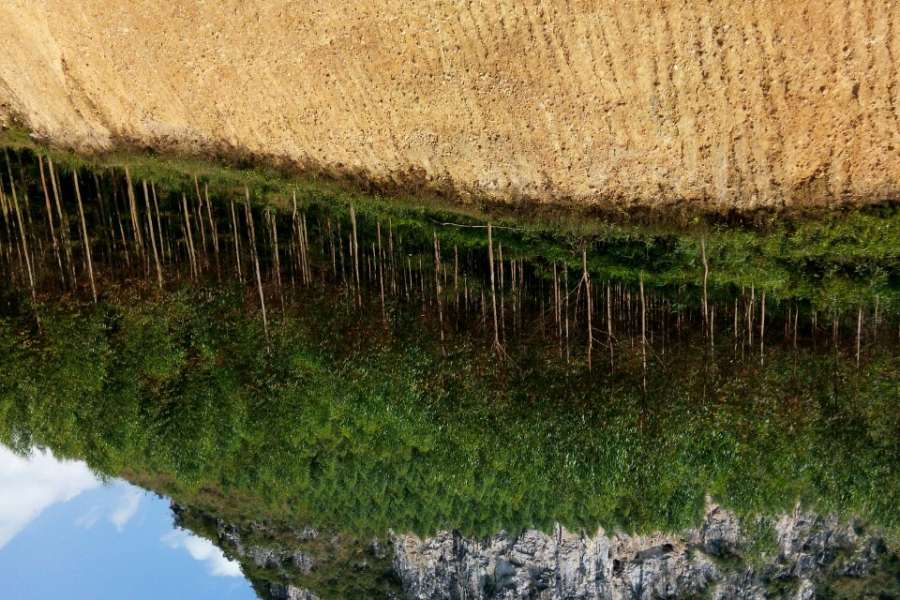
0;0;900;210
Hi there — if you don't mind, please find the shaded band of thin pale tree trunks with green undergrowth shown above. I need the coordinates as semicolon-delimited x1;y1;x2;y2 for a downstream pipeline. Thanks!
0;150;900;374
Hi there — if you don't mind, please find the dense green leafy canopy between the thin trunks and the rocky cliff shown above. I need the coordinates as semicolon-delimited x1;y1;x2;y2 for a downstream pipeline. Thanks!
0;278;900;533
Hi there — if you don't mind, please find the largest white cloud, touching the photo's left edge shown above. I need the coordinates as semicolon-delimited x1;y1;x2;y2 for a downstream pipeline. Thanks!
0;446;101;548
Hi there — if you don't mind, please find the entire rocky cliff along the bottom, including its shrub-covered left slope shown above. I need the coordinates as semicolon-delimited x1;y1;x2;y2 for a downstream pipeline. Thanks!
178;505;900;600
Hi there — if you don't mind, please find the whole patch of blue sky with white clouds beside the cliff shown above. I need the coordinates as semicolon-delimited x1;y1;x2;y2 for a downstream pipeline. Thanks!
0;446;256;600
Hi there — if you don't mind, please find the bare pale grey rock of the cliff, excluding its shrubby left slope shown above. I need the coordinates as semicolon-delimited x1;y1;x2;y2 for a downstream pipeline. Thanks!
392;504;885;600
